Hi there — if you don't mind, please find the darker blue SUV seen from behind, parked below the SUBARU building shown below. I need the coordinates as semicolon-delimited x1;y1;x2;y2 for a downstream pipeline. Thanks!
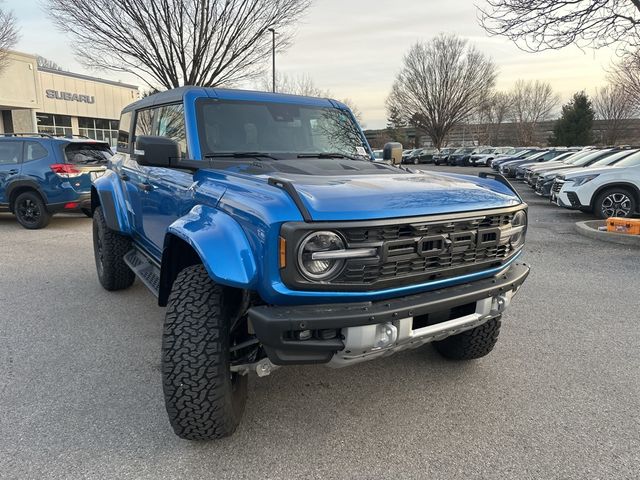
0;133;112;229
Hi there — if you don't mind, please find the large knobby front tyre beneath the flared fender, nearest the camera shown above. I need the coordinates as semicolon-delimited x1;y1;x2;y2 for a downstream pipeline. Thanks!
162;265;247;440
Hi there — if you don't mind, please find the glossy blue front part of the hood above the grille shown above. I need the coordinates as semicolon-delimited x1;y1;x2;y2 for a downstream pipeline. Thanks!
268;172;521;221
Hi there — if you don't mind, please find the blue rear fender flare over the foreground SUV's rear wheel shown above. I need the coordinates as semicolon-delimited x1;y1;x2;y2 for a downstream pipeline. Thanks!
91;170;131;235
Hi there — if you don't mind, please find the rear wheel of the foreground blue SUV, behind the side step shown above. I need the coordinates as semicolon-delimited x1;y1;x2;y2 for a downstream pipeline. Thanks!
93;207;135;290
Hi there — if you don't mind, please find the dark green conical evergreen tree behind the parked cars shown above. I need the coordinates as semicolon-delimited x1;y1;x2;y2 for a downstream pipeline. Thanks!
549;91;595;147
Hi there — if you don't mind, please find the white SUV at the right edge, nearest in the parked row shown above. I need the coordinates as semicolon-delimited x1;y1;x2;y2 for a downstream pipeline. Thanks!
551;152;640;218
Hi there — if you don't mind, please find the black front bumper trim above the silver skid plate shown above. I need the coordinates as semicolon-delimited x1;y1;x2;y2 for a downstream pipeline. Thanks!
248;264;529;365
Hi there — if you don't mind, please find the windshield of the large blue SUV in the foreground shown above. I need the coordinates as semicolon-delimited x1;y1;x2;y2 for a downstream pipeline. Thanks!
198;100;370;158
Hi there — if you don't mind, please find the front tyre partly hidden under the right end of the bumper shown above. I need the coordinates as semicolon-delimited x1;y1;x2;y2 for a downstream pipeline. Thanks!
433;317;501;360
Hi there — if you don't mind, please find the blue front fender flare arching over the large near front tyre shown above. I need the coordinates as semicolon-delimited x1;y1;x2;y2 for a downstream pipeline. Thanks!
165;205;257;289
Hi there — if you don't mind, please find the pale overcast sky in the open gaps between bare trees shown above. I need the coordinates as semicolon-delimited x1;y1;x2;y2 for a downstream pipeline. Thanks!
4;0;613;128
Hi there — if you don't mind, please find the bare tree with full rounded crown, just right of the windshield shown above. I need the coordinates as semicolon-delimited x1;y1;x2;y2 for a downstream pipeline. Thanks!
387;35;496;148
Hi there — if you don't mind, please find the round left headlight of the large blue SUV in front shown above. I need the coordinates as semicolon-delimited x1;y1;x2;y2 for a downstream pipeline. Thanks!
298;231;345;282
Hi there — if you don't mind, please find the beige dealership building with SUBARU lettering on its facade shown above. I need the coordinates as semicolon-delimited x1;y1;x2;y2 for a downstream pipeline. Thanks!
0;52;138;146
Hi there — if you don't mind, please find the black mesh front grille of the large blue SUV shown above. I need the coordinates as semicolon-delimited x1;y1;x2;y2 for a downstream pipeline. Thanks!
283;209;516;291
